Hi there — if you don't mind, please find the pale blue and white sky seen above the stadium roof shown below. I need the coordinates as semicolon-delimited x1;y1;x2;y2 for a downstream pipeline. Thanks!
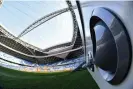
0;0;73;49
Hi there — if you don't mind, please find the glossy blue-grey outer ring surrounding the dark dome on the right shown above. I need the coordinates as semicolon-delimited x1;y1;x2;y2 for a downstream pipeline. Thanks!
90;7;132;84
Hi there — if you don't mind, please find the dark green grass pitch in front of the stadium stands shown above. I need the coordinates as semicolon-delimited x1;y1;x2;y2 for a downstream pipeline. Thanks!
0;67;99;89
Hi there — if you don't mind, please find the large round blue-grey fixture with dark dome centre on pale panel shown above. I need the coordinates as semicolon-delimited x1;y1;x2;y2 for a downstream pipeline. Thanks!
90;8;131;84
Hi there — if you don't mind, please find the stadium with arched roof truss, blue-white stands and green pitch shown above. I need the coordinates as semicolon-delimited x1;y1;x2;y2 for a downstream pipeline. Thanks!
0;1;97;89
